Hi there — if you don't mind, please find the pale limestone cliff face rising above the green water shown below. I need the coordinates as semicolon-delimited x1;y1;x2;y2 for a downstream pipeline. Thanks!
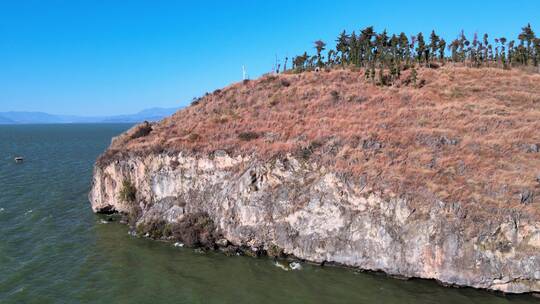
89;153;540;293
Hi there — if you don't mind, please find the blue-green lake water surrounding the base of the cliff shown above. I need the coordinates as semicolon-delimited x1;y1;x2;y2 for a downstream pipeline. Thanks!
0;124;537;304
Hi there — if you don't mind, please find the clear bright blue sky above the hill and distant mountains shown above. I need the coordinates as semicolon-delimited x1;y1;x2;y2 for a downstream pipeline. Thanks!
0;0;540;115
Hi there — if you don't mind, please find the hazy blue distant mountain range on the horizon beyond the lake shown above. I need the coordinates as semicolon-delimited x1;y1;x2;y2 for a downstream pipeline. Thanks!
0;108;180;124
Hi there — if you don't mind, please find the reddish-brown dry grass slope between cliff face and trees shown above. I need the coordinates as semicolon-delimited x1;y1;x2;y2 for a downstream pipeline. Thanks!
101;66;540;214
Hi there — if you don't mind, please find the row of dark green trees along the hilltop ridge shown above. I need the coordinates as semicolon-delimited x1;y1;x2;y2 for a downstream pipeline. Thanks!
284;24;540;84
